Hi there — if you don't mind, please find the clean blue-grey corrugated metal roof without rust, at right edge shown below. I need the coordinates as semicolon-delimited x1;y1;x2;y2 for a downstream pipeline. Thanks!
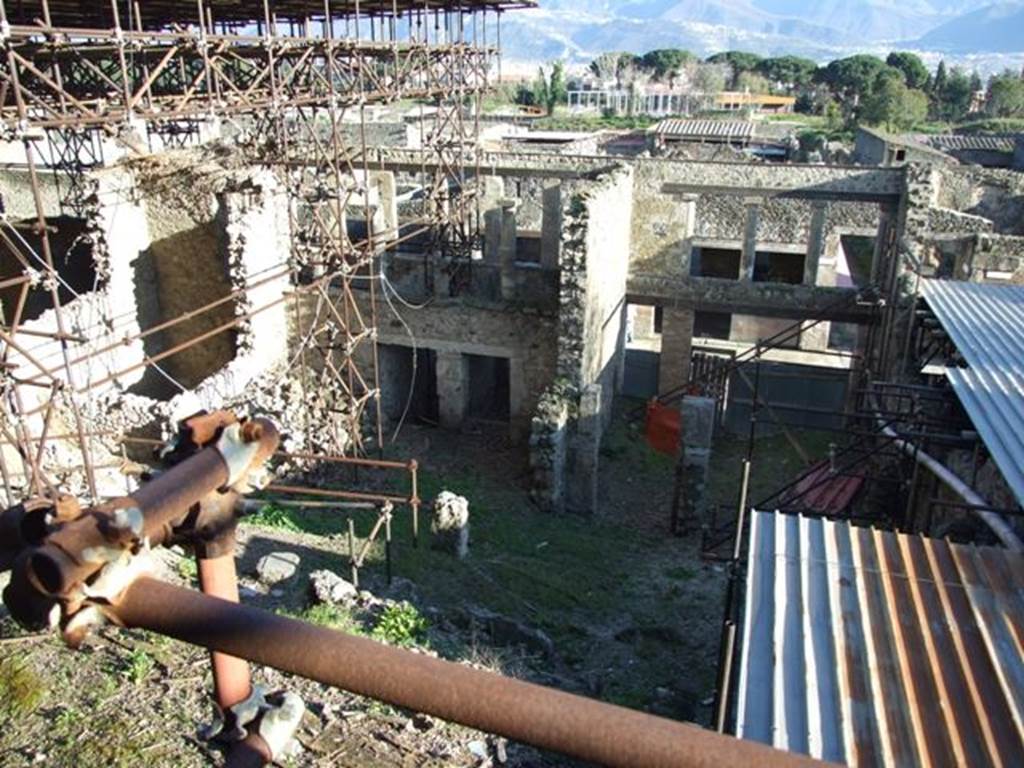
923;280;1024;512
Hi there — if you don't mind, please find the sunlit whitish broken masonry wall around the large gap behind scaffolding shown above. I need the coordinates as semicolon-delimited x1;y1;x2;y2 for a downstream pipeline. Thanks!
5;161;289;495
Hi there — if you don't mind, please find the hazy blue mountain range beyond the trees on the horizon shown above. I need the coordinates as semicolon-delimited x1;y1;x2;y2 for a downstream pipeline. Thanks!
502;0;1024;70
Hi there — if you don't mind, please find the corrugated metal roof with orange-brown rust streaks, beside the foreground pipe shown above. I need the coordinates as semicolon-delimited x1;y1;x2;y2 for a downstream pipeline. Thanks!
737;512;1024;768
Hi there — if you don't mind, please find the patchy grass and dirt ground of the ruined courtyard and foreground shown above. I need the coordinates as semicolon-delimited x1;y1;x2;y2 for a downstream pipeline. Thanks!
0;403;815;768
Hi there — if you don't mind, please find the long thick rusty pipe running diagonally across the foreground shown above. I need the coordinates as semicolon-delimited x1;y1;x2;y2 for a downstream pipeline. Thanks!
111;579;822;768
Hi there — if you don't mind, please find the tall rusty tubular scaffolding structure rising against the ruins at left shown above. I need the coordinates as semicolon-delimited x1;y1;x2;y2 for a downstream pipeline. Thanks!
0;0;535;512
